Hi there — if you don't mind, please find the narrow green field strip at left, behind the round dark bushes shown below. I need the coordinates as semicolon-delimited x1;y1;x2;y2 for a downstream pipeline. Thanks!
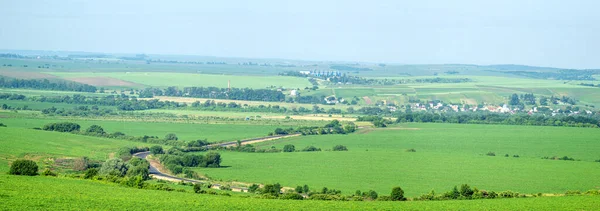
0;118;277;142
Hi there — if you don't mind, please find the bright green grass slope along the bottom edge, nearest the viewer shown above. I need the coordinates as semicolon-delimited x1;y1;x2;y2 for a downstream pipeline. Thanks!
0;175;600;210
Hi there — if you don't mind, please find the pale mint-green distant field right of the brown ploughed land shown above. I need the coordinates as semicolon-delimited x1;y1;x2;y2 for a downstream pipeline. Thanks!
50;72;312;89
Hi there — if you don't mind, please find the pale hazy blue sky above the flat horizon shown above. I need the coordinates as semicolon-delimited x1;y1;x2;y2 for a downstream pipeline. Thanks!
0;0;600;68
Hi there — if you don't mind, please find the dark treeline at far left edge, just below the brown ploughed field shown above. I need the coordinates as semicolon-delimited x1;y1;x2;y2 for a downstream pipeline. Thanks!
0;76;97;92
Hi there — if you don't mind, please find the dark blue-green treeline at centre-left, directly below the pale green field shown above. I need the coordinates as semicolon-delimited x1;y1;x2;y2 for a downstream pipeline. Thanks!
139;86;285;102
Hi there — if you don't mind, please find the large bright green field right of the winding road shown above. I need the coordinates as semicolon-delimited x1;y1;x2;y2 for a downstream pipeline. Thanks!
196;124;600;196
